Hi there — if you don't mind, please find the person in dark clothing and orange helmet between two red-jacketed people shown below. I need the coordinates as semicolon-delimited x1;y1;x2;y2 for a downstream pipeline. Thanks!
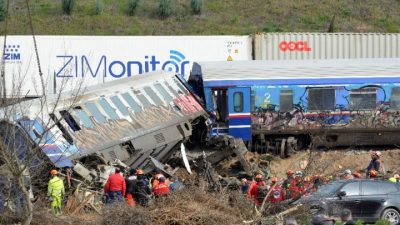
133;169;151;206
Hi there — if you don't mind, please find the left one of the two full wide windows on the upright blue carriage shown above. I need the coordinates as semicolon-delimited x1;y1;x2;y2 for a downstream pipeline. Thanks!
308;88;335;110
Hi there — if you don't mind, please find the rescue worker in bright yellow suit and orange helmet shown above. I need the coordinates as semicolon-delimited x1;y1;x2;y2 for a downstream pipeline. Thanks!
47;169;65;215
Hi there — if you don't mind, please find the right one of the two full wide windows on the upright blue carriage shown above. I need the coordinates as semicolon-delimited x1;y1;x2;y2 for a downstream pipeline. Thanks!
349;88;376;110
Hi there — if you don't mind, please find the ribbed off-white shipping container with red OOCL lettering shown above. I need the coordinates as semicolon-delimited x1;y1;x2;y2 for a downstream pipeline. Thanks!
254;33;400;60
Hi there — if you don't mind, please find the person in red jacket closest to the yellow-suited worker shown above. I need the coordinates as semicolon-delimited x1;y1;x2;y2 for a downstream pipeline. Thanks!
104;167;126;203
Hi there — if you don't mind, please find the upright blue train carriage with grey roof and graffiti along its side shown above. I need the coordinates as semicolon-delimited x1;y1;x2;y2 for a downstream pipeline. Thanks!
189;58;400;157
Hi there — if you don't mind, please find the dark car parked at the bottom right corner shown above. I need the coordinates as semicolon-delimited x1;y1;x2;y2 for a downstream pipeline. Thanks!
296;179;400;224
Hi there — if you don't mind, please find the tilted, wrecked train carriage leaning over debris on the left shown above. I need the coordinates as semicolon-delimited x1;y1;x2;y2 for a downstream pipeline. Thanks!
2;72;208;181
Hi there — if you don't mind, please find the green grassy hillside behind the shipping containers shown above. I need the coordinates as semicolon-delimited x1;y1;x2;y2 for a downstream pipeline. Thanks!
0;0;400;35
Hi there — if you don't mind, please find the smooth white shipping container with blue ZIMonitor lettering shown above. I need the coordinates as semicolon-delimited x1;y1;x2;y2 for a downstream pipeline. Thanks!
0;36;252;96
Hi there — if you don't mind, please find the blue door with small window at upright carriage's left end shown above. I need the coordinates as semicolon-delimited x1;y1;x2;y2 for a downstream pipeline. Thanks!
228;87;251;141
